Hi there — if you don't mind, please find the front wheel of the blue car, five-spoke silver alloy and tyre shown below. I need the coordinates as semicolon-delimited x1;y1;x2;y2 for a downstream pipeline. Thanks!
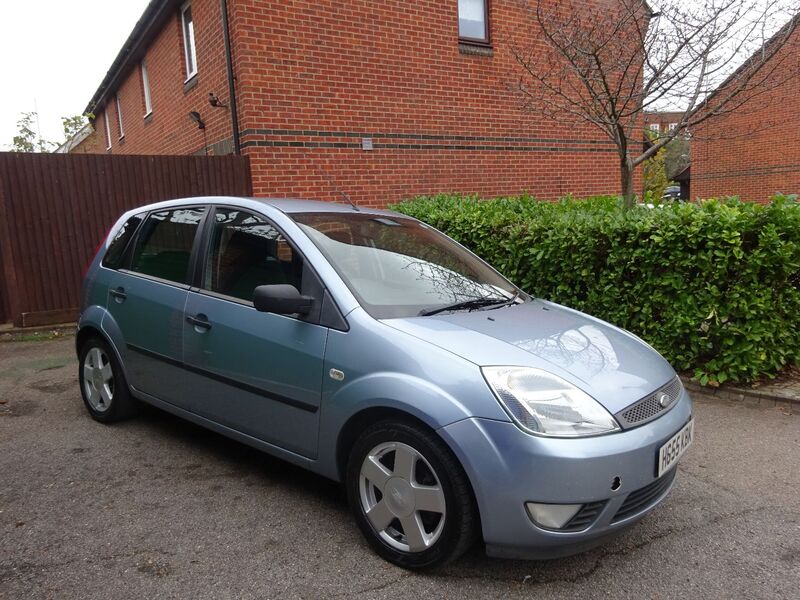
346;421;479;570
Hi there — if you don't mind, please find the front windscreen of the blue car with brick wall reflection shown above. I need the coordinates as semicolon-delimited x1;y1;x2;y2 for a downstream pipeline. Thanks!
293;213;528;319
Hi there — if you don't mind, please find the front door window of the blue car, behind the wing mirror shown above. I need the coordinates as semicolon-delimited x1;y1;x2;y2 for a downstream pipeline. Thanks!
203;208;303;302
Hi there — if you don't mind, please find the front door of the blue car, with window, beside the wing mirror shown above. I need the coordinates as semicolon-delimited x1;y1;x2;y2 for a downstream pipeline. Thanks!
183;207;328;458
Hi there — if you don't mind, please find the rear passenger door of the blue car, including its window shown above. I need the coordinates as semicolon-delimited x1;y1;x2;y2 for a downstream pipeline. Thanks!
106;207;207;408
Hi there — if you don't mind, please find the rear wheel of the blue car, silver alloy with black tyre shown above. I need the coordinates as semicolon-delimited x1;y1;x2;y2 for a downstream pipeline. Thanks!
78;337;136;423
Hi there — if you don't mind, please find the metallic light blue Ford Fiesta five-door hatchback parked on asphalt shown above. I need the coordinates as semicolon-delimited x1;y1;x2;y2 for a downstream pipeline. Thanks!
76;197;693;568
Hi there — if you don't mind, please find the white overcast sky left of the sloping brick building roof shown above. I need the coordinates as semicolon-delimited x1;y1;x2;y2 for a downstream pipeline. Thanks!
0;0;149;150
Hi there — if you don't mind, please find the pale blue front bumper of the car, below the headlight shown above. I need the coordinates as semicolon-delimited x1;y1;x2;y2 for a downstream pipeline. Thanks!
439;390;692;559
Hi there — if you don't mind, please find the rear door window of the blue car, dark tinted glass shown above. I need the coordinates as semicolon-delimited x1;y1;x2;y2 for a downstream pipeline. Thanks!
131;208;205;283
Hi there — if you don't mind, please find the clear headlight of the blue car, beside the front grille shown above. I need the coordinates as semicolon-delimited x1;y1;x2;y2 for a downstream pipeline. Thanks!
481;367;619;437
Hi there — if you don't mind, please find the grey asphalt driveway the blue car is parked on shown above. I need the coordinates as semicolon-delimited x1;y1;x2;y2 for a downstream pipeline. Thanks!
0;338;800;600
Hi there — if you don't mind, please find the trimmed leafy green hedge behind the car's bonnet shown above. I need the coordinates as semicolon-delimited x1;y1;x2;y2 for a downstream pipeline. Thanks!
394;195;800;385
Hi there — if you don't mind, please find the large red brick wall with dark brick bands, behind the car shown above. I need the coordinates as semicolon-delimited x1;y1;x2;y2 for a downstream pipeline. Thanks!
234;0;618;205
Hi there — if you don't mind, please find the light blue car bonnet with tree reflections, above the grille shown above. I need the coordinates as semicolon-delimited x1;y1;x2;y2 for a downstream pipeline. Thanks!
383;300;675;414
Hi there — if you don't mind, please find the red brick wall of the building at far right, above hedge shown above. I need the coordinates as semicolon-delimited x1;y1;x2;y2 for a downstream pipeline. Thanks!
692;30;800;202
